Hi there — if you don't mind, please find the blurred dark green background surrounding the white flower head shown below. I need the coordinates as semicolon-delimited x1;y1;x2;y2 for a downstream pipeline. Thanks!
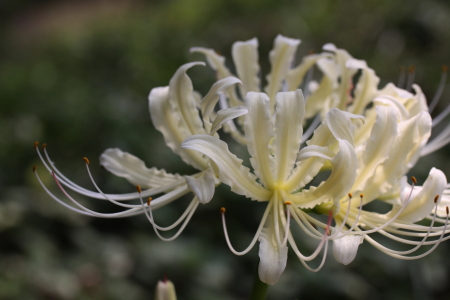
0;0;450;300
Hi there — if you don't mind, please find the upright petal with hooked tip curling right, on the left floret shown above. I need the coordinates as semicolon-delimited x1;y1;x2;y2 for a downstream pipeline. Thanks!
169;62;206;135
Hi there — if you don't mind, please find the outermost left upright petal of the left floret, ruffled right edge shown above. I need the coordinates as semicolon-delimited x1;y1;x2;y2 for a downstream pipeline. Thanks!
148;86;208;170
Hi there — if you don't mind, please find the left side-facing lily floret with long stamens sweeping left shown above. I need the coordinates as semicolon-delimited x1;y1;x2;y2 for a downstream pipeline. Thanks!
33;62;247;241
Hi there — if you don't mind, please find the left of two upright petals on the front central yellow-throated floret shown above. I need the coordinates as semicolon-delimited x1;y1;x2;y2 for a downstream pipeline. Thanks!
244;92;274;189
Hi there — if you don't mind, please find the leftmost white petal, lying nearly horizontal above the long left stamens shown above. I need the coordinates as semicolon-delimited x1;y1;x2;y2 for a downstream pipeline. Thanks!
100;148;183;188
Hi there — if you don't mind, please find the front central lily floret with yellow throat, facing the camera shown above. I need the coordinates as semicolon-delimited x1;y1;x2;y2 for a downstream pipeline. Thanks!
183;90;361;284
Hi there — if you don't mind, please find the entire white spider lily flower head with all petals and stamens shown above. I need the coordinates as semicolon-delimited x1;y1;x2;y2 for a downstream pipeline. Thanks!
35;35;450;284
